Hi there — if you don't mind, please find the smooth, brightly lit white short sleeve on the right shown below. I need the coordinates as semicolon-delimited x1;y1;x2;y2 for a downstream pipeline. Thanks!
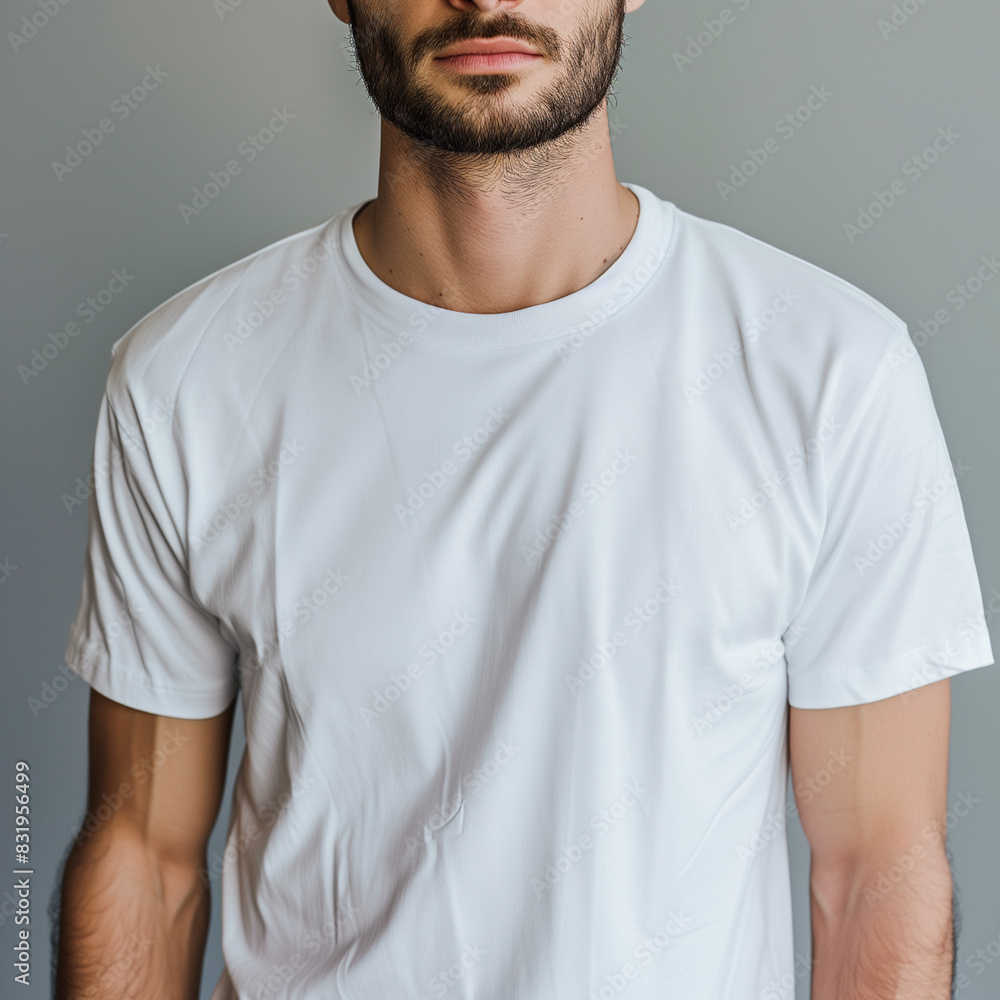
783;321;993;708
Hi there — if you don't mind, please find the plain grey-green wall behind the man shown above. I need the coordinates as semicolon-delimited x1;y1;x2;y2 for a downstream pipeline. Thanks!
0;0;1000;1000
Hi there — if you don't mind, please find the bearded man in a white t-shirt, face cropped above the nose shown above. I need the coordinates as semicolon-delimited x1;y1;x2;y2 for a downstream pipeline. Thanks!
57;0;993;1000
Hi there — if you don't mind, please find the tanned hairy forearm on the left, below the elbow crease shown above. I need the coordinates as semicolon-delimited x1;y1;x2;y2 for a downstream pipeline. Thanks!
55;831;210;1000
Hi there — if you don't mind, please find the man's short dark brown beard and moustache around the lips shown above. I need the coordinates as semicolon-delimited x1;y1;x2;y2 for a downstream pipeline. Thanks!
347;0;625;157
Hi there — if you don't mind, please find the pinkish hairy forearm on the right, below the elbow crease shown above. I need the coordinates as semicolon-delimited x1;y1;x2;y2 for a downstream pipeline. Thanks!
811;835;954;1000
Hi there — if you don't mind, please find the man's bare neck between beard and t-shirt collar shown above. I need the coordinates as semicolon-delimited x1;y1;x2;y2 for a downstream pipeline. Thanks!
354;105;639;313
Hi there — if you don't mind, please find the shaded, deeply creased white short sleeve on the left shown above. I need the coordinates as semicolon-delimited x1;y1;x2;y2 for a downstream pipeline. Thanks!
65;390;239;719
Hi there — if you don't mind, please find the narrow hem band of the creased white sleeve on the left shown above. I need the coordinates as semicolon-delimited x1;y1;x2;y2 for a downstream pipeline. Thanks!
65;637;239;719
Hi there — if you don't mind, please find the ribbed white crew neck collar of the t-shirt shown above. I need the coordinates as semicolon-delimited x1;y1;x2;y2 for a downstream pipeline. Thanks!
331;183;675;351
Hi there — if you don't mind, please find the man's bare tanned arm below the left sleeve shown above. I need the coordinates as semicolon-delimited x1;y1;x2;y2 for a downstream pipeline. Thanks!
55;689;236;1000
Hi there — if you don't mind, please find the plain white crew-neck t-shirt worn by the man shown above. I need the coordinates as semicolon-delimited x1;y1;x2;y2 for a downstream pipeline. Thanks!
66;184;993;1000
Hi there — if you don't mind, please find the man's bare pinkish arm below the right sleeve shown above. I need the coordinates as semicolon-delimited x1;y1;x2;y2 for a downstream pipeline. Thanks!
789;679;953;1000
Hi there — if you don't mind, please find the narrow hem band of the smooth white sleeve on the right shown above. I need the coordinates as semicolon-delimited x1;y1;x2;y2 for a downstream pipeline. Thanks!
788;634;995;708
